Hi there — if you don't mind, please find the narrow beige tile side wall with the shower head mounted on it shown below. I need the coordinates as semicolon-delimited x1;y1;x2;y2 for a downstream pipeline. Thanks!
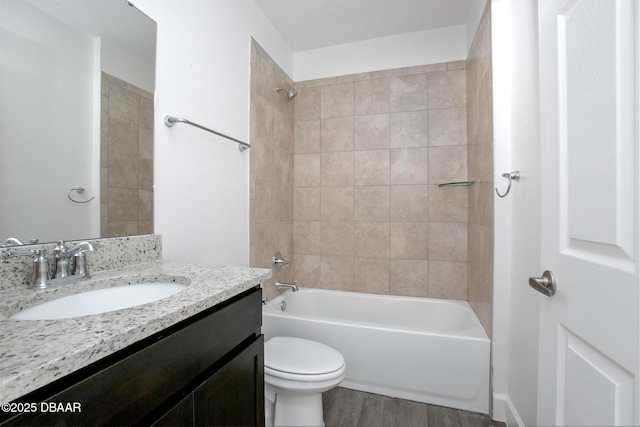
249;40;295;298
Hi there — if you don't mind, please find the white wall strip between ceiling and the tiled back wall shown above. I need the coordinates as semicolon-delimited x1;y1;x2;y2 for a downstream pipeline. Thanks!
293;25;469;81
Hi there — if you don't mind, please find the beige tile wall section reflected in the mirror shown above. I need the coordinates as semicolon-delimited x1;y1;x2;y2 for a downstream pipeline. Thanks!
100;73;154;237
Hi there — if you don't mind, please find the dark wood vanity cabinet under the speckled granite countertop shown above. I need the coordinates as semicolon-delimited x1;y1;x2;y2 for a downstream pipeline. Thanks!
2;287;264;426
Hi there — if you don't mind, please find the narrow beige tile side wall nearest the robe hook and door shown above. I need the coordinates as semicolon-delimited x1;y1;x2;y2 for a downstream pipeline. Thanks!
467;2;494;337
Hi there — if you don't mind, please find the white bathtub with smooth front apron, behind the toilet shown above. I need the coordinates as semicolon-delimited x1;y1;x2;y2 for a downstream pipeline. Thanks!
262;288;490;414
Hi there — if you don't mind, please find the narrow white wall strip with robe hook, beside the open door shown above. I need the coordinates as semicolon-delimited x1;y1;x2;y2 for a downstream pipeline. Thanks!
492;0;545;426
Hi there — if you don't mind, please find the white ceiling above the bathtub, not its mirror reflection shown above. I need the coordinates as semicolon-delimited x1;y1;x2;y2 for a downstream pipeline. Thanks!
255;0;479;52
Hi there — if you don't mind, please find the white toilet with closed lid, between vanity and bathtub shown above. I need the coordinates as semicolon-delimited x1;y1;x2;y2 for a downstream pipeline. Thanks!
264;337;346;427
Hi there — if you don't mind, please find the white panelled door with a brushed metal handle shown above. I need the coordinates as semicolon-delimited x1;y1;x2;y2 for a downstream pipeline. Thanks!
532;0;640;426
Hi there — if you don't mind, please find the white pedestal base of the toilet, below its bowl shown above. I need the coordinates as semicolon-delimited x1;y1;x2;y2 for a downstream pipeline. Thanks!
273;393;324;427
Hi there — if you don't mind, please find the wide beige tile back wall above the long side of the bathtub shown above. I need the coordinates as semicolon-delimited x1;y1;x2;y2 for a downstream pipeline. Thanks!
293;61;469;300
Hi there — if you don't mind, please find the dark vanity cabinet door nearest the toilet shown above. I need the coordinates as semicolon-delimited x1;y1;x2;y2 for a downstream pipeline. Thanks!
194;335;264;426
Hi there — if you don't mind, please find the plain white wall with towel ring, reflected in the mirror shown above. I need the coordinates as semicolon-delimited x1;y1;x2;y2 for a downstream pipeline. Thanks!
0;0;95;242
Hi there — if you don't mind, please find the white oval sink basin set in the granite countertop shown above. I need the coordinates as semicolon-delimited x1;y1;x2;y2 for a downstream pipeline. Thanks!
11;282;188;320
